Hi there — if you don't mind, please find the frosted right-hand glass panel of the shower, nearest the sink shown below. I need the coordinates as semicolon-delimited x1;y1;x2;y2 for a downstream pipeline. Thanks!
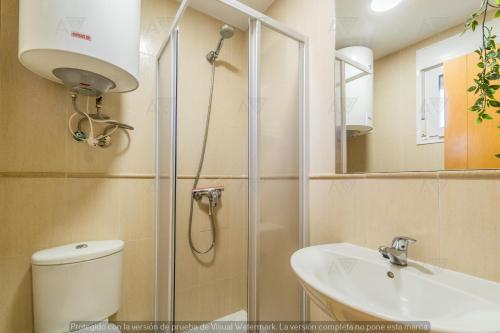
256;23;302;321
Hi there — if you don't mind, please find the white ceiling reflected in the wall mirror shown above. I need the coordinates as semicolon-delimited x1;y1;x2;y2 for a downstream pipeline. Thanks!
336;0;481;59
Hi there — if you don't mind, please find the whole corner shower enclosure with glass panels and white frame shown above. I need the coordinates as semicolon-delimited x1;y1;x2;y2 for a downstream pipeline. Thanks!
156;0;308;322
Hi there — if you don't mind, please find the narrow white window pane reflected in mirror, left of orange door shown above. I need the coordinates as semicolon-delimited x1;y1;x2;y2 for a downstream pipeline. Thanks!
417;64;447;145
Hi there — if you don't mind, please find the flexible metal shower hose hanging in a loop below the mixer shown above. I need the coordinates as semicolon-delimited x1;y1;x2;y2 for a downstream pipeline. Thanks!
189;61;216;254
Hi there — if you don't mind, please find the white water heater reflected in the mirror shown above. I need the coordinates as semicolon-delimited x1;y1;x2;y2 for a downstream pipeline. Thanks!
337;46;373;135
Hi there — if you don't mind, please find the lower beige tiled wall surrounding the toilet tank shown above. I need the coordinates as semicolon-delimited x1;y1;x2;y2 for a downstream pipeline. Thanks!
0;178;154;326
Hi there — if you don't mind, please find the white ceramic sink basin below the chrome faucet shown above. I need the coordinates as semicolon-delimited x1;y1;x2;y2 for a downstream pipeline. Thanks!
291;243;500;333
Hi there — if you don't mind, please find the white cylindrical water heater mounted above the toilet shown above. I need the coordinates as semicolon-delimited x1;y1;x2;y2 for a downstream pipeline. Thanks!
18;0;141;96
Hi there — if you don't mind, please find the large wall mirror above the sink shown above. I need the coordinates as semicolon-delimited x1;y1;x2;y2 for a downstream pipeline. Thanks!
335;0;500;173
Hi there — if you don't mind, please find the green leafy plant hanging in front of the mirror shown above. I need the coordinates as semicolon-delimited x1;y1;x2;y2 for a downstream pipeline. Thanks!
464;0;500;158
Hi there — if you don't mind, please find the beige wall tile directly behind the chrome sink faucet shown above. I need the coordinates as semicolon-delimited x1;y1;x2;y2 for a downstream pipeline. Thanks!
360;179;439;262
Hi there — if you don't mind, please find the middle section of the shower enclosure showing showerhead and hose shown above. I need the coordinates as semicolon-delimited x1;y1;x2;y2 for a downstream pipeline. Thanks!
175;3;248;322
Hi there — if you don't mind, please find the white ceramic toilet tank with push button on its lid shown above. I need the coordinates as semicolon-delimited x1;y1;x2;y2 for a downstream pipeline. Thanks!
31;240;124;333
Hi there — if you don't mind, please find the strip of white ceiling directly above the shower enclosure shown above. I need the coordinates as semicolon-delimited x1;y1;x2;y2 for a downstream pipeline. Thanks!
181;0;274;30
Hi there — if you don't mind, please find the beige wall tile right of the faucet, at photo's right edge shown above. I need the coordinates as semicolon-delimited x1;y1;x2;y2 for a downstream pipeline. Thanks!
439;179;500;282
